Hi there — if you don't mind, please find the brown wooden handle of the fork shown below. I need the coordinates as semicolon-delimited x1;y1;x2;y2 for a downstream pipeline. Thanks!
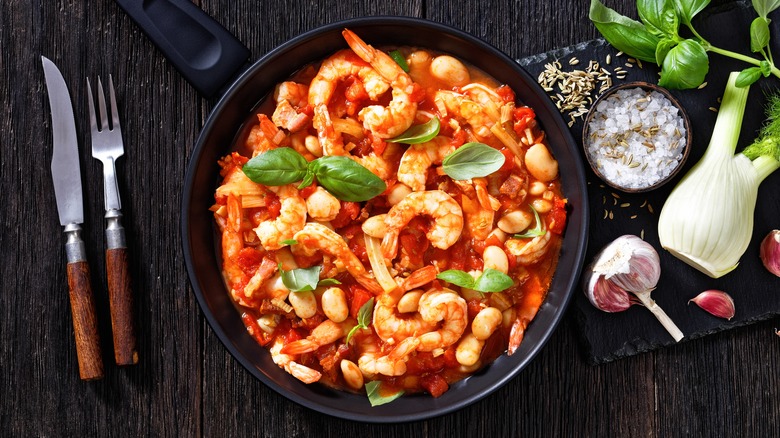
106;248;138;365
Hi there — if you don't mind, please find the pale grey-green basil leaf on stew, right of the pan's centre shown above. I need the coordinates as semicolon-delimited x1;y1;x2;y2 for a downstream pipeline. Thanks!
441;143;506;180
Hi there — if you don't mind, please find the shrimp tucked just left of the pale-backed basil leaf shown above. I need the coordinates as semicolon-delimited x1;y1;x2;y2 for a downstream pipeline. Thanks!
398;136;455;192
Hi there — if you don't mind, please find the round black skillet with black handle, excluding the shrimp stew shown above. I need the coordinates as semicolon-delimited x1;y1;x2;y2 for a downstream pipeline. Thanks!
118;0;588;423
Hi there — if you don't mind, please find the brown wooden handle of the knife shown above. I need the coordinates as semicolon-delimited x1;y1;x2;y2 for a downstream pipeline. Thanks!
68;261;103;380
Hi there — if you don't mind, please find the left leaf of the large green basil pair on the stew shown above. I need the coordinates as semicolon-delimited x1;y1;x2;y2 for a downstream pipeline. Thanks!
241;148;309;186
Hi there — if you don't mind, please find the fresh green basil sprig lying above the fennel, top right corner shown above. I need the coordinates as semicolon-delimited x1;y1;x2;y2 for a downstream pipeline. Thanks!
589;0;780;89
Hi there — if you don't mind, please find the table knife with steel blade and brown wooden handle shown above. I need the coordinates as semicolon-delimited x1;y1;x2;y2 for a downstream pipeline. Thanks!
41;56;103;380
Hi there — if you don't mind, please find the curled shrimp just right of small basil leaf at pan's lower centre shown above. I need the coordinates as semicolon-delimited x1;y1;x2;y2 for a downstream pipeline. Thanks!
373;294;436;342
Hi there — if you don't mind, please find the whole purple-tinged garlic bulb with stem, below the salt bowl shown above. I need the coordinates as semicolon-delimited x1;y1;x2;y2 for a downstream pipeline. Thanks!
583;234;684;341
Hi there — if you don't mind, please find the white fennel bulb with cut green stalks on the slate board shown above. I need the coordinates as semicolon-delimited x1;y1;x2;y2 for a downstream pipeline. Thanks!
658;72;780;278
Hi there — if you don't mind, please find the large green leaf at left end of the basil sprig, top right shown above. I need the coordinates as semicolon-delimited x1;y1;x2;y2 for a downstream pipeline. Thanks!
588;0;659;62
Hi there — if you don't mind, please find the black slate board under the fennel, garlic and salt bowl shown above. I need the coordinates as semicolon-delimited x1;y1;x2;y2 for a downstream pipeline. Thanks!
519;2;780;363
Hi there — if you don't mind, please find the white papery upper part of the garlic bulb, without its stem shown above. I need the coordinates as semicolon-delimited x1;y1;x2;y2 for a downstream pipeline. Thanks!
593;234;661;293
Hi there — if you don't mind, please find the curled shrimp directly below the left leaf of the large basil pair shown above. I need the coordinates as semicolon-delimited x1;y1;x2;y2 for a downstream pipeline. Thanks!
255;184;306;250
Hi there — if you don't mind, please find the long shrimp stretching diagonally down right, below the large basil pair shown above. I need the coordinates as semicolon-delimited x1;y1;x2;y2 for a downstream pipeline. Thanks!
292;222;384;295
